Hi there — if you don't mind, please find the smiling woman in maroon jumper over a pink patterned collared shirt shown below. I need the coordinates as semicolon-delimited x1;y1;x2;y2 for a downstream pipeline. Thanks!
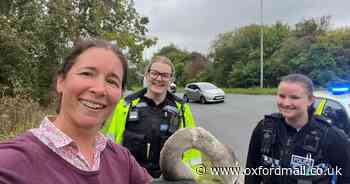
0;40;151;184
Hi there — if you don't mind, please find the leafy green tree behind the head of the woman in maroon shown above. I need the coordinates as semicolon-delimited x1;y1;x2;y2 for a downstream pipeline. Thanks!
0;0;156;103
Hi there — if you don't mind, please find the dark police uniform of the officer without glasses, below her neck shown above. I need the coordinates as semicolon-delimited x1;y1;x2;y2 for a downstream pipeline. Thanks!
245;113;350;184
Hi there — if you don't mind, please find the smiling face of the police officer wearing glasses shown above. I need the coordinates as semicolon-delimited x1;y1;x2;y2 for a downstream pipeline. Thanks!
146;62;172;95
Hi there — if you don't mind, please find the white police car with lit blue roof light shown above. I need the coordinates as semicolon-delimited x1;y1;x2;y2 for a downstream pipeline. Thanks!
313;88;350;135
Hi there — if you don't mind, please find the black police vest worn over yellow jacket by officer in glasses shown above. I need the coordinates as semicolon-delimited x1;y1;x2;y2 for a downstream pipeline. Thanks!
123;89;183;178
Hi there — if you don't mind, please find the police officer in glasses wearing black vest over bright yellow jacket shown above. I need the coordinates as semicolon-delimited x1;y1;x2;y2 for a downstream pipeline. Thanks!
103;56;200;178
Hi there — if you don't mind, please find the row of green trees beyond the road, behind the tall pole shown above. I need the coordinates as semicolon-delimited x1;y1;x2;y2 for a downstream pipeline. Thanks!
206;16;350;87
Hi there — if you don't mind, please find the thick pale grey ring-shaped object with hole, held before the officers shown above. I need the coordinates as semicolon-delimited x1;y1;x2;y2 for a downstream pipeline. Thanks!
152;127;243;184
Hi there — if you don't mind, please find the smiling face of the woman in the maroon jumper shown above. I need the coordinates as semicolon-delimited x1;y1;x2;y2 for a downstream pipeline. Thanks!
57;48;123;128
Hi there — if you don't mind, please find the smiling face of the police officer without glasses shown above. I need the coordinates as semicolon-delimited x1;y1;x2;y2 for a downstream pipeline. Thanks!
277;81;314;122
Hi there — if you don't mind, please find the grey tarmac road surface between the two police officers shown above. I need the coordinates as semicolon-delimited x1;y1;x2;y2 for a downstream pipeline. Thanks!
182;94;277;165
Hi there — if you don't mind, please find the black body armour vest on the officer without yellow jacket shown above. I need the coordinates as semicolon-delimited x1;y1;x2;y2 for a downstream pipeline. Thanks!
260;114;332;184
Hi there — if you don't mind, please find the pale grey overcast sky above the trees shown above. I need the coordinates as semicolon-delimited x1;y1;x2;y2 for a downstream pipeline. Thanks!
134;0;350;58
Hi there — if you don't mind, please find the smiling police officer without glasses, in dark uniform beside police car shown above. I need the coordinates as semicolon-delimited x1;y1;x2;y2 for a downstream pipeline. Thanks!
245;74;350;184
